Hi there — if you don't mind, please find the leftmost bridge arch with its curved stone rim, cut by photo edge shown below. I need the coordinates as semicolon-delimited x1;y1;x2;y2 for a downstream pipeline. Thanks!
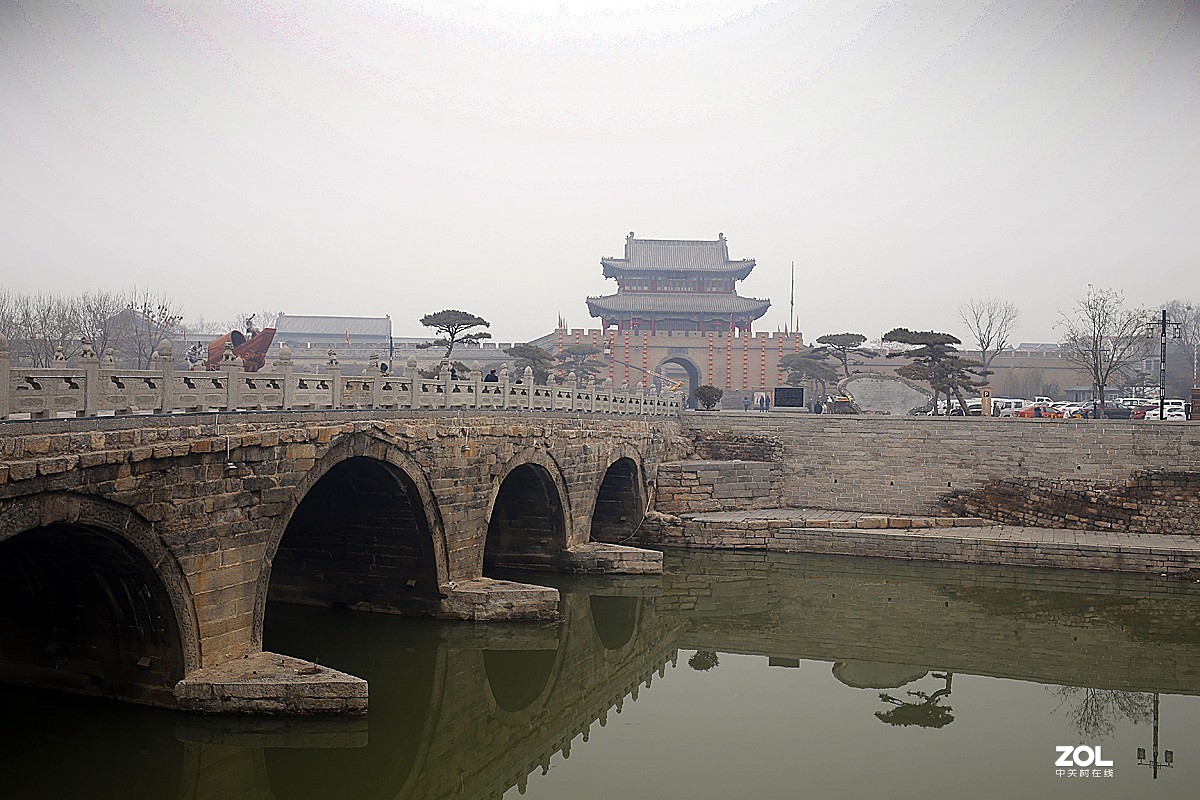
0;493;202;706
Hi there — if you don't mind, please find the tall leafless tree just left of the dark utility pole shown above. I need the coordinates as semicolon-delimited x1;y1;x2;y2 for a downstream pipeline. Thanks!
1061;284;1150;419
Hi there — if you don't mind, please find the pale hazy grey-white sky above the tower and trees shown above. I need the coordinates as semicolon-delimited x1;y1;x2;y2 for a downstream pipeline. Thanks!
0;0;1200;341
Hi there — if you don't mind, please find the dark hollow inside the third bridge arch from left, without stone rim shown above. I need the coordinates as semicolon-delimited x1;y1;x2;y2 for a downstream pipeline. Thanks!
484;464;566;575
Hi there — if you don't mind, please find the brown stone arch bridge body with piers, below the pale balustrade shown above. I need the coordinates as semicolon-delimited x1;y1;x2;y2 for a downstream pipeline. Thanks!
0;410;689;714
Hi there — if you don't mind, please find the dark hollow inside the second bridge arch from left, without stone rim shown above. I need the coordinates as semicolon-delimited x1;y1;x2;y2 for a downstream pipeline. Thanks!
268;457;438;614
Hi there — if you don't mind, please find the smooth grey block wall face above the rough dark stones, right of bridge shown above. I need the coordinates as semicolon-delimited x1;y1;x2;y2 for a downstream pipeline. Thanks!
684;414;1200;515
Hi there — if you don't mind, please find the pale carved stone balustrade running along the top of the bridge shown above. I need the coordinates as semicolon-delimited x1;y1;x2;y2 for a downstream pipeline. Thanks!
0;336;680;420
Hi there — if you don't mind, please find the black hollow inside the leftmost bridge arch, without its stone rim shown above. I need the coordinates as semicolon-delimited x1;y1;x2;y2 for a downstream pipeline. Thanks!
0;524;185;706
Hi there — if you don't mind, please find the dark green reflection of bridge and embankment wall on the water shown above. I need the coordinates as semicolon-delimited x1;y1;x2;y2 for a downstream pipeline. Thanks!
0;552;1200;800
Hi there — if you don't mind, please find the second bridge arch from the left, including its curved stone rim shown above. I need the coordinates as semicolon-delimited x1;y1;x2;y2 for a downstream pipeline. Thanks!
253;433;449;646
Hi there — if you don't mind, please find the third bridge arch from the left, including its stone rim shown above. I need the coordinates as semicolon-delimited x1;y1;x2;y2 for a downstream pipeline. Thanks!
482;449;572;573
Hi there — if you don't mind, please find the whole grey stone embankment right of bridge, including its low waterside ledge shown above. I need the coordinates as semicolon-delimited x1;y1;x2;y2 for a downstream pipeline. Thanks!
632;414;1200;575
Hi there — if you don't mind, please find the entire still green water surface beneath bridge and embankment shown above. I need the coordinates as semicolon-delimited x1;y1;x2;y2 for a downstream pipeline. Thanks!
0;553;1200;800
